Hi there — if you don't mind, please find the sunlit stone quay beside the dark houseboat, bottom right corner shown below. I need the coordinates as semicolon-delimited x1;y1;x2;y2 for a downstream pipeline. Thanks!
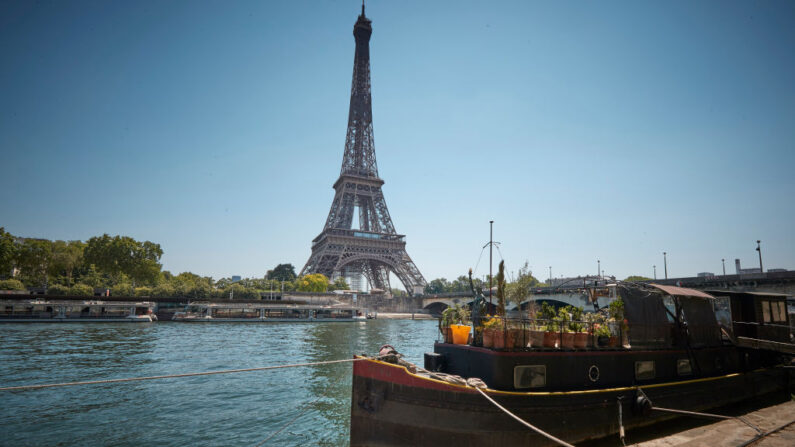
627;400;795;447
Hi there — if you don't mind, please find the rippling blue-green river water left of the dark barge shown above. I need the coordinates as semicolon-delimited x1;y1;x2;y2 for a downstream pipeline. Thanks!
0;320;438;446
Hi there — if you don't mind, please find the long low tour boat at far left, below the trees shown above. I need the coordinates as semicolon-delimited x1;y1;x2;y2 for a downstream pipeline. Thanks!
0;299;157;323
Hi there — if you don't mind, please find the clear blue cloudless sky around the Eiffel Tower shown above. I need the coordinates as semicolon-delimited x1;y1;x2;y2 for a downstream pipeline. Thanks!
0;0;795;280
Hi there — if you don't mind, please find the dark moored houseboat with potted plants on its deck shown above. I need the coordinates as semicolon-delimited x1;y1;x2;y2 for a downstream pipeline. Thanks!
350;283;795;446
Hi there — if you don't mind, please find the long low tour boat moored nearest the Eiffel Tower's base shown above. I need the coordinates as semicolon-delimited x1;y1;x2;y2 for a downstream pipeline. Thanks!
172;303;366;323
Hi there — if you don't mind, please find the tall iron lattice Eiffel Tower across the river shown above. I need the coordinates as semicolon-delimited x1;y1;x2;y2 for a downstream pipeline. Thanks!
301;4;426;294
